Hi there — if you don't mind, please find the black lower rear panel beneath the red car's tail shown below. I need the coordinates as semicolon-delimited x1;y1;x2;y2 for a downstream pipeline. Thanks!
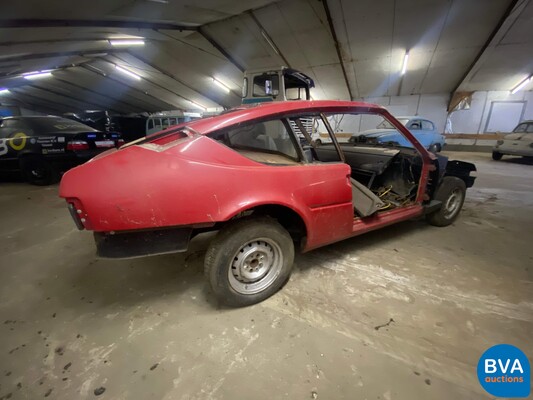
94;227;193;258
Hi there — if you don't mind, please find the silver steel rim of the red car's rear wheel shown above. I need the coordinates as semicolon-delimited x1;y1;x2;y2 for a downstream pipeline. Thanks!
228;238;283;294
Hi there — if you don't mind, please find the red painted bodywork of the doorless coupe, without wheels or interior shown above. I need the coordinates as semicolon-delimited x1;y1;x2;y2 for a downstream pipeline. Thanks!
60;101;475;306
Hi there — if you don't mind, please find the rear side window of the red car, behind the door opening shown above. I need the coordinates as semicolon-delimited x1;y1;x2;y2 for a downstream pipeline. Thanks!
215;120;299;161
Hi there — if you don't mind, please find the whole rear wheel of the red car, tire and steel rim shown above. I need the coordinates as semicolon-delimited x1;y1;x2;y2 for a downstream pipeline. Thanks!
204;217;294;307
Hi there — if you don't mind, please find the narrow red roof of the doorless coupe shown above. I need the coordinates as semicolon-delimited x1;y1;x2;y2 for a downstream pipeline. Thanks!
181;100;386;135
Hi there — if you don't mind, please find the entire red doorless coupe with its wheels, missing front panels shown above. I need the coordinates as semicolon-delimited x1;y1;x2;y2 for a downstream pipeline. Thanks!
60;101;476;306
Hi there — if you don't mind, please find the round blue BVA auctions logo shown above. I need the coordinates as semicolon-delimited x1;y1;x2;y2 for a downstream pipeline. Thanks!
477;344;531;397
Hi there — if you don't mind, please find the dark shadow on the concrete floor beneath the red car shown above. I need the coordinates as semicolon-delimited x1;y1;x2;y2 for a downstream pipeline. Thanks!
50;212;433;311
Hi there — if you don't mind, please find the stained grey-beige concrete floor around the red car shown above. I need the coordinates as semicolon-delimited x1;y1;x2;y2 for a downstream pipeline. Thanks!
0;153;533;400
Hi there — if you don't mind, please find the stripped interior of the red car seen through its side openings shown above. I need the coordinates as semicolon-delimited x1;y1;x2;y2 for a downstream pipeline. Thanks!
211;117;422;217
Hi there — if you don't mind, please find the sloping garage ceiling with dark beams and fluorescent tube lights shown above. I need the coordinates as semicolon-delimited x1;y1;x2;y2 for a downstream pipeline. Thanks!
0;0;533;114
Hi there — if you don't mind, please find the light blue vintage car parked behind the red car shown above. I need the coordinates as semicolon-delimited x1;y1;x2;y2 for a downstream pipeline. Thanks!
350;117;445;153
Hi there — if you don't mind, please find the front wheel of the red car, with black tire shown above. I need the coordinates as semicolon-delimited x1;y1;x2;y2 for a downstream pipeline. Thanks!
426;176;466;226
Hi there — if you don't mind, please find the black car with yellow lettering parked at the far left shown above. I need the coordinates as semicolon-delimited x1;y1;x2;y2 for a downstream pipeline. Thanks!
0;116;124;185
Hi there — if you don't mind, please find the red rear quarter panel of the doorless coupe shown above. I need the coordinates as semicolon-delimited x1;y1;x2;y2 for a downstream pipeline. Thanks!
60;136;353;252
